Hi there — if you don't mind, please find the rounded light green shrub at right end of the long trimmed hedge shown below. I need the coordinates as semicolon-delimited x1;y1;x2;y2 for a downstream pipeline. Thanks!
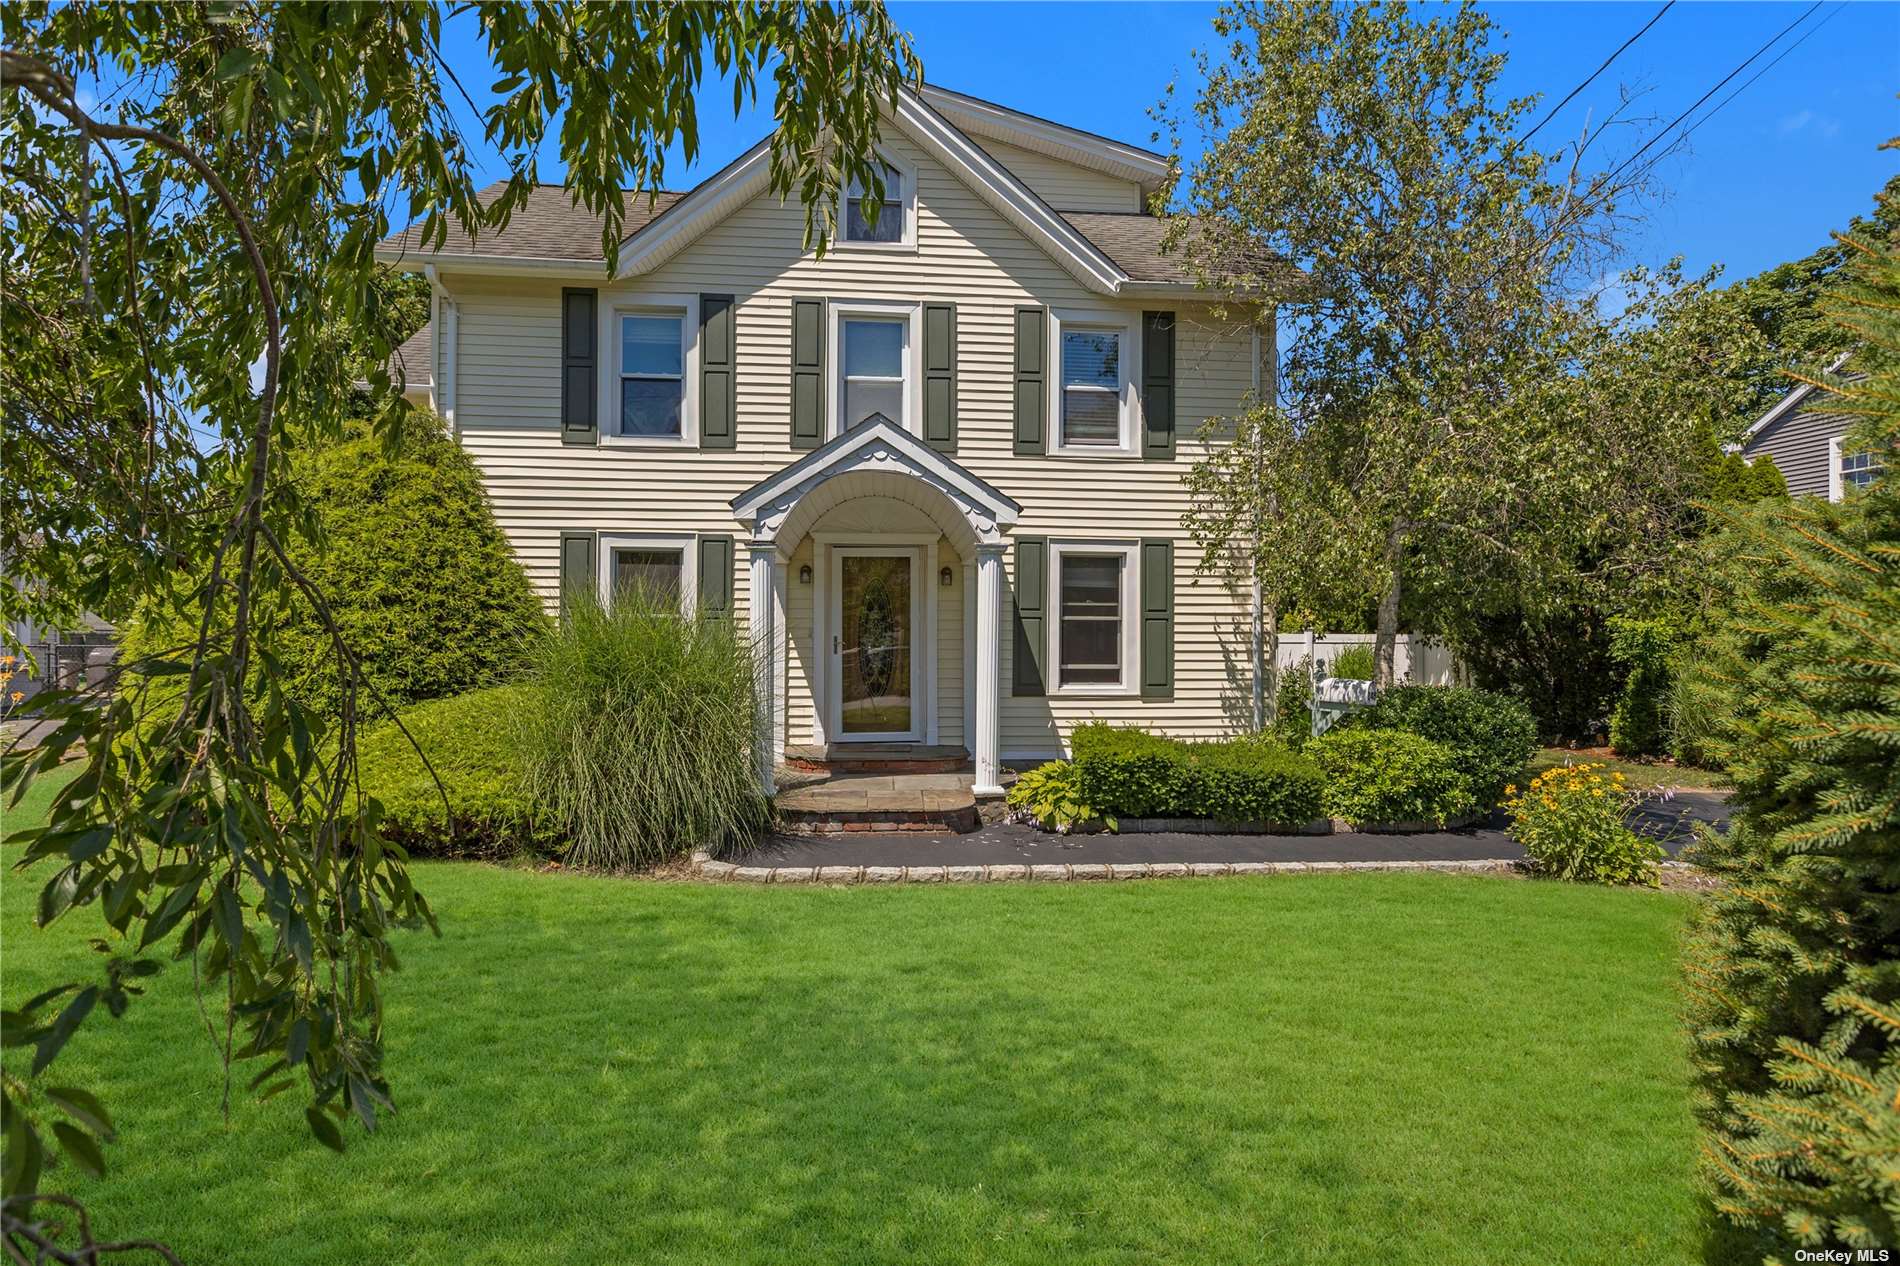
1305;726;1473;827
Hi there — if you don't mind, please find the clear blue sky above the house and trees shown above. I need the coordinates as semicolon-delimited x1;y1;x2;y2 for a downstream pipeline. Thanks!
435;0;1900;279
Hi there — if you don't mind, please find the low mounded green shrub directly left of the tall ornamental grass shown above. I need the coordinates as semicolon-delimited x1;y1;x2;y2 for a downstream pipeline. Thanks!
357;684;564;859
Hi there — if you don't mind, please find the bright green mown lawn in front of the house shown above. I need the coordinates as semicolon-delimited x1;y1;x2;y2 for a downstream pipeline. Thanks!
0;790;1699;1266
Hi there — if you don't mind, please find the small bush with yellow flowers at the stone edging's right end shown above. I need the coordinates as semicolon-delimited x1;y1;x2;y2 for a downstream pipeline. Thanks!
1505;762;1663;888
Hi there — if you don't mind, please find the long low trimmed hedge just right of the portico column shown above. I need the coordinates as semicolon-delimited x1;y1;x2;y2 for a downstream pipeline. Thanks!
1070;722;1322;827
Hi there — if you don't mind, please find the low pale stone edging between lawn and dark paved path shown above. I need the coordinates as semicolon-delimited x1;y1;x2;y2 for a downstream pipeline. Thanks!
694;852;1524;884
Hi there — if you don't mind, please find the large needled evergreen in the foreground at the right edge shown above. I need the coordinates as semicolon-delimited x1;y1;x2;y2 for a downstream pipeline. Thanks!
1687;439;1900;1239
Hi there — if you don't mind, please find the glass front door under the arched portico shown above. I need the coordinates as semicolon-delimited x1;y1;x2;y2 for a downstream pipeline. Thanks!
830;546;923;743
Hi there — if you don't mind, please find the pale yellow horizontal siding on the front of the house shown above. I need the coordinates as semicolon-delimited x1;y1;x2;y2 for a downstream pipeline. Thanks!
447;125;1252;758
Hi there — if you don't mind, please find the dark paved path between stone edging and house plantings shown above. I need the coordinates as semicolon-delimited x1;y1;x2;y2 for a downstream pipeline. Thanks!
728;791;1727;867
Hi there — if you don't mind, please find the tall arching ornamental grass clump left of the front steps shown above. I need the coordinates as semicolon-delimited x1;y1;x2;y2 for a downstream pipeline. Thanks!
523;591;771;869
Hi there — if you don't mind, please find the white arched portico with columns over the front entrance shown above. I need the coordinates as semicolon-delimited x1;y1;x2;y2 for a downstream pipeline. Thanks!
732;420;1022;796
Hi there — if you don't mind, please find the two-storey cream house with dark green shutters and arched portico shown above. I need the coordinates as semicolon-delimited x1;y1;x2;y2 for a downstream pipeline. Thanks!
378;87;1275;796
